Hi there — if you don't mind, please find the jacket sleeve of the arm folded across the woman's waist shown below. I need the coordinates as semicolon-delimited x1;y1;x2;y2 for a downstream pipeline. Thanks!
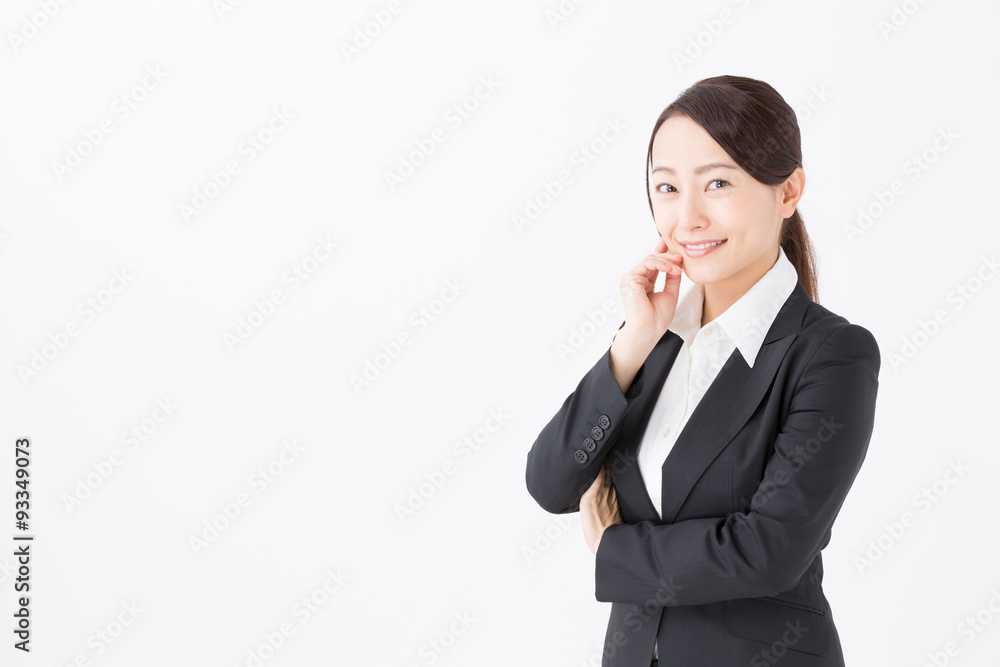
595;323;881;605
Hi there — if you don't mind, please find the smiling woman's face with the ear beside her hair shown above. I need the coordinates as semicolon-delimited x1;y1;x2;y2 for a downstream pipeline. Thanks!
649;116;804;290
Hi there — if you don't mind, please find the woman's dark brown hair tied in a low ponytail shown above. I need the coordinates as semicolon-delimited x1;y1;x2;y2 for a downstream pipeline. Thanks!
646;75;819;303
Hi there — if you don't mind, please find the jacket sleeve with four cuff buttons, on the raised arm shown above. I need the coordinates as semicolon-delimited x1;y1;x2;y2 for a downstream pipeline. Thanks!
525;322;646;514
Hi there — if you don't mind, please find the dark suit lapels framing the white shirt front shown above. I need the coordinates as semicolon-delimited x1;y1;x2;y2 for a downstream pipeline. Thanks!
612;282;812;523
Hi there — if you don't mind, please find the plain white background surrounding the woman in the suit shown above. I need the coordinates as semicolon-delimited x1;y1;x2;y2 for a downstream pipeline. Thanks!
0;0;1000;667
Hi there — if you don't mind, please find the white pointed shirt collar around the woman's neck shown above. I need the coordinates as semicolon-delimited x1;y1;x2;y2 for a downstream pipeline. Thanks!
667;246;799;368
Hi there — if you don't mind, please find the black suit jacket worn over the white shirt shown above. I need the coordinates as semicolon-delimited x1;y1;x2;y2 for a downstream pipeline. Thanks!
526;282;881;667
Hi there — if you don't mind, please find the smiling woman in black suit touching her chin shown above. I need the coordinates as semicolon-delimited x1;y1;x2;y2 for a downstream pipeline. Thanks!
526;76;881;667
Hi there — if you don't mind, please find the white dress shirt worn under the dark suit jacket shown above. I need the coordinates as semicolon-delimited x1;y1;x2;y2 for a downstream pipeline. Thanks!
638;246;799;657
